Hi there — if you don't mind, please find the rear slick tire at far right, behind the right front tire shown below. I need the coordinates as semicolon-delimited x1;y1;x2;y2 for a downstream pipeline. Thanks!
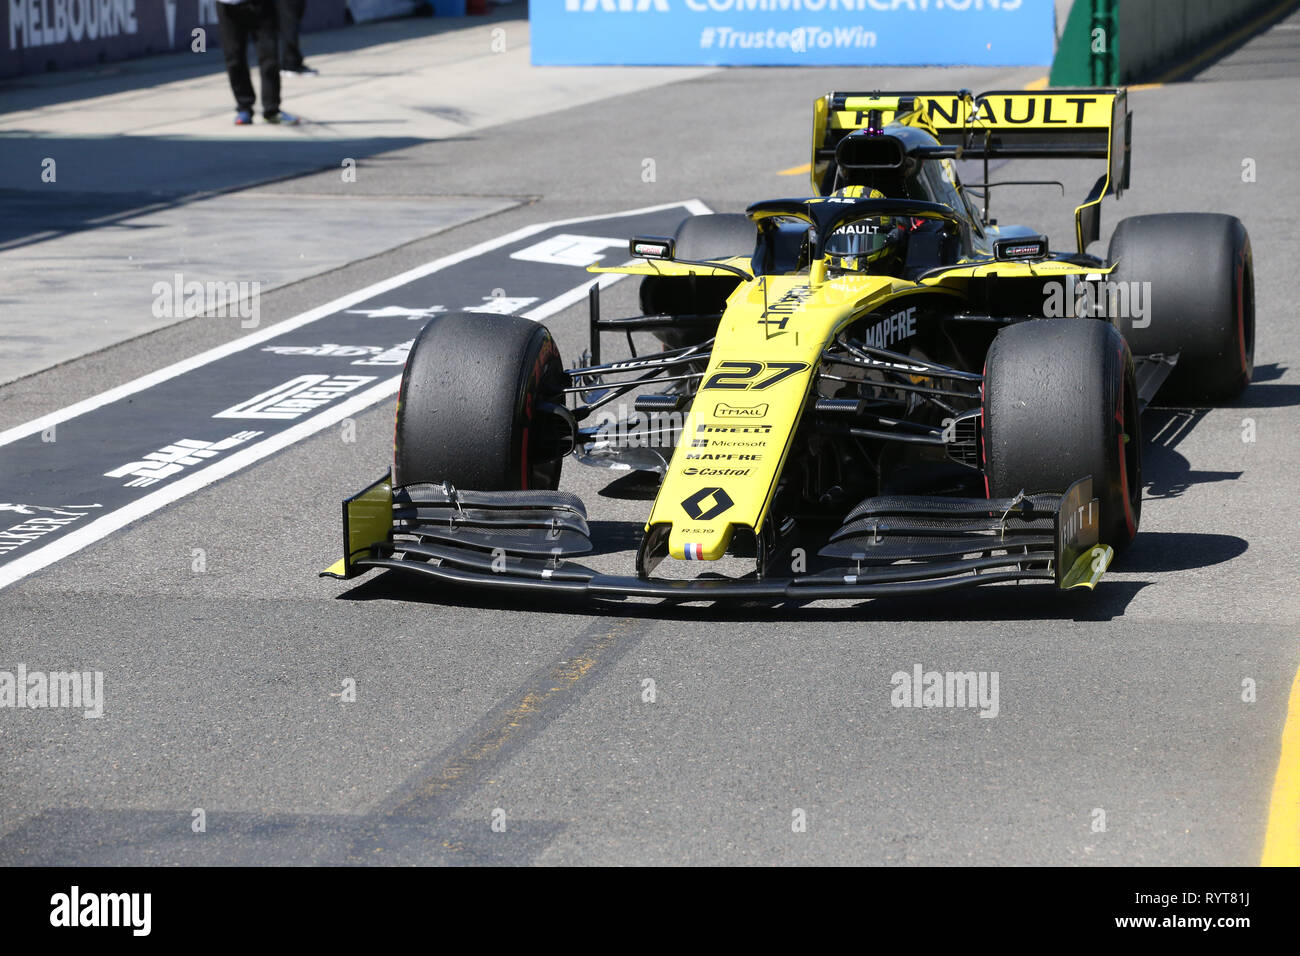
1106;212;1255;402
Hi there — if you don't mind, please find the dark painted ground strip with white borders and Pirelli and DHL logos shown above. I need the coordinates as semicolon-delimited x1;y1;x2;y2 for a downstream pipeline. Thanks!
0;200;705;588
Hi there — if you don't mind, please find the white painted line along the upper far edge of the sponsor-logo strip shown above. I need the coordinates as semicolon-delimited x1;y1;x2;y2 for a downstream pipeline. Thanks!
0;199;710;445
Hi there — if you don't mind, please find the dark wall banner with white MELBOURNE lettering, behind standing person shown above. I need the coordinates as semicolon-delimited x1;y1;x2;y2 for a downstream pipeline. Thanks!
0;0;347;77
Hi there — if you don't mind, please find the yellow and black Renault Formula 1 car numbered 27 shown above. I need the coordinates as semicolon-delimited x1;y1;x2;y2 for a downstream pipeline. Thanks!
332;90;1255;600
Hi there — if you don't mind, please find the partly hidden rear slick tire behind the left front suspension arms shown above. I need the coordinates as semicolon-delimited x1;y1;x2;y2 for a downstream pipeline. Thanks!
641;212;758;349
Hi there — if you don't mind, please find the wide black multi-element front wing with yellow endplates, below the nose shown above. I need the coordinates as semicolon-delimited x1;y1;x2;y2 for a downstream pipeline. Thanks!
322;476;1113;601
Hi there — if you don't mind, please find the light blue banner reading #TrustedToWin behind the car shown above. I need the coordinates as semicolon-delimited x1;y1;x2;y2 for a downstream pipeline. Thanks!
529;0;1056;66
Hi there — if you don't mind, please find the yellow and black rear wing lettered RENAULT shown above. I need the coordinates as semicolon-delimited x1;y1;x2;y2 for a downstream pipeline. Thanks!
813;88;1132;252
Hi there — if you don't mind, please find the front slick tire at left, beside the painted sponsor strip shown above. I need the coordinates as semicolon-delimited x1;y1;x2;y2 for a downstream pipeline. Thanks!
393;312;566;492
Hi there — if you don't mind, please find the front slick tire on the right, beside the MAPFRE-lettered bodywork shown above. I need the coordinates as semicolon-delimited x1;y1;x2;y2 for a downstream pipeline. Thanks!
983;319;1141;553
